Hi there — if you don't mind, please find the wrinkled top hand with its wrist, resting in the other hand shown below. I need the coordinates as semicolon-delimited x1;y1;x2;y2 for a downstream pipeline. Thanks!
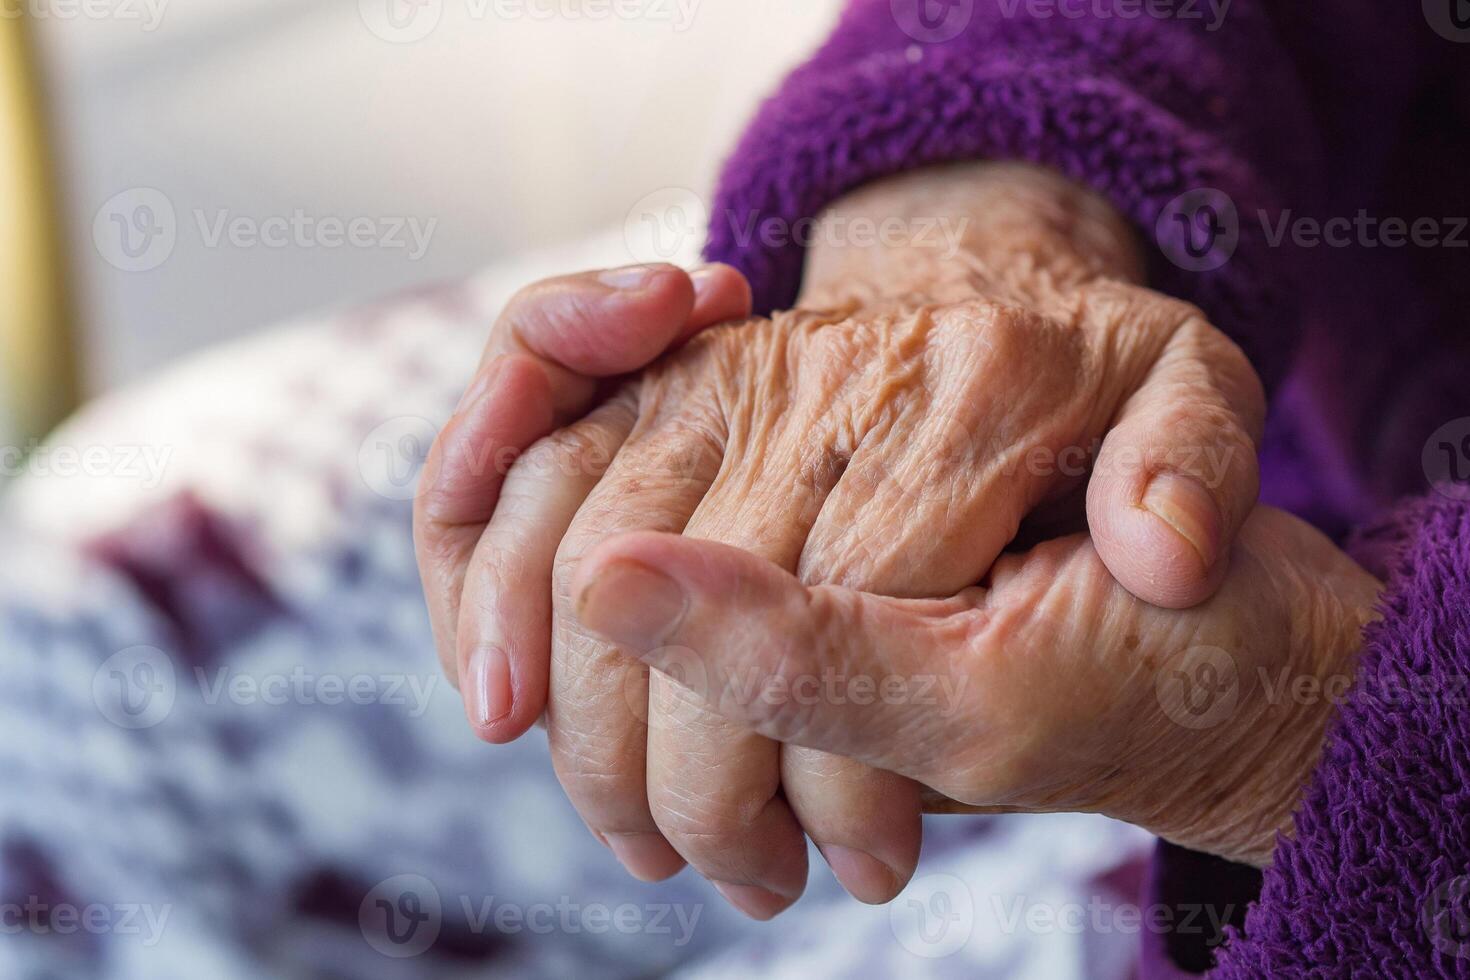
420;166;1263;915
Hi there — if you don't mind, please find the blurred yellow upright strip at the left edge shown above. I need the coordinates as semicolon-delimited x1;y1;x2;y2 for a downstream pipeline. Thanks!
0;9;78;447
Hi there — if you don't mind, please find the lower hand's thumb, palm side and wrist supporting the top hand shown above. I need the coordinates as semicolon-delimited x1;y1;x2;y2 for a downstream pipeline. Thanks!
573;508;1382;865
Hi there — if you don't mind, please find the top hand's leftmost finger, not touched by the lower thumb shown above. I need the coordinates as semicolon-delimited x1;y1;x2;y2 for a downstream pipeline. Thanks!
457;392;637;742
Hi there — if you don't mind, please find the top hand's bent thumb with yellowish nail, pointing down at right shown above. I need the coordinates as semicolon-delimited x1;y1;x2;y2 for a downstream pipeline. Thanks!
1088;320;1266;608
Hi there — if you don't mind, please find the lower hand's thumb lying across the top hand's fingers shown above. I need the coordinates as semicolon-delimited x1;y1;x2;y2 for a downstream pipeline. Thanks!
572;532;980;782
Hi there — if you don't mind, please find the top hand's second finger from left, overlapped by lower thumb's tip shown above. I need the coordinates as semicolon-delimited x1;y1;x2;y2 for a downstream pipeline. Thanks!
547;423;723;880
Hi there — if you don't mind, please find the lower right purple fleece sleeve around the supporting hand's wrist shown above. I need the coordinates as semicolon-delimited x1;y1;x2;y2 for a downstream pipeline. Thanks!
1142;488;1470;980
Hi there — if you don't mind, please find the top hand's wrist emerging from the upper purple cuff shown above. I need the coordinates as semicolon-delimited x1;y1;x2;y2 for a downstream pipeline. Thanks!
798;162;1142;307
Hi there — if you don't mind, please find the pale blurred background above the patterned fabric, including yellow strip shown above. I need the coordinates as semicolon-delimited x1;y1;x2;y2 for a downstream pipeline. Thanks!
0;0;838;445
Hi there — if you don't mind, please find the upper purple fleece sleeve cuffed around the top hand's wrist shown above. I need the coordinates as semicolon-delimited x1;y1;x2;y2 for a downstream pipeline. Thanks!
706;0;1434;385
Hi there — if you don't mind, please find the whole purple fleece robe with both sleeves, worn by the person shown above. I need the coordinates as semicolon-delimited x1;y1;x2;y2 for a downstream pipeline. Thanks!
707;0;1470;977
